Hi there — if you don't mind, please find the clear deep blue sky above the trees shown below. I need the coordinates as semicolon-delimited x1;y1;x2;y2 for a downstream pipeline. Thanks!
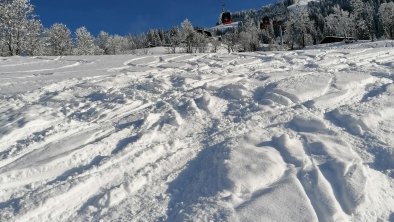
31;0;275;35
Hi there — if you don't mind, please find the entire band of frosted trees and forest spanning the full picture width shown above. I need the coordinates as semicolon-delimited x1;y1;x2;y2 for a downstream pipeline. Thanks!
0;0;394;56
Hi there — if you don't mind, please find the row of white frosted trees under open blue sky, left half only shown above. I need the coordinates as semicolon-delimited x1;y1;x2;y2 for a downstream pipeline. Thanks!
0;0;225;56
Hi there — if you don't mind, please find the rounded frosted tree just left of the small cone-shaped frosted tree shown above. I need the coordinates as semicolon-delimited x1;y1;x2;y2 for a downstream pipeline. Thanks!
48;23;72;55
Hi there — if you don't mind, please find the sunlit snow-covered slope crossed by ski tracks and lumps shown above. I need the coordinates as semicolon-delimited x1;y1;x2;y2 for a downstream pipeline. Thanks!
0;41;394;222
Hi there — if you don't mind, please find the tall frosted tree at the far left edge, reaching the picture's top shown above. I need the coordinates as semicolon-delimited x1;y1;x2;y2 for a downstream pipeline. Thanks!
0;0;33;56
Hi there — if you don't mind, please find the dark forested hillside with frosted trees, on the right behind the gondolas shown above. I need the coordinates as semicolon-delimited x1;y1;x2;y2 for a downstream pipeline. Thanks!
228;0;394;49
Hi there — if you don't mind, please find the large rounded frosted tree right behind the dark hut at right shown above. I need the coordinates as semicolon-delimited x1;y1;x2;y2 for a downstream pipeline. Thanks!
325;5;355;37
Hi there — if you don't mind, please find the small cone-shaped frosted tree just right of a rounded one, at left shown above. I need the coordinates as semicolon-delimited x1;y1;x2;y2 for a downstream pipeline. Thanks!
74;27;103;55
